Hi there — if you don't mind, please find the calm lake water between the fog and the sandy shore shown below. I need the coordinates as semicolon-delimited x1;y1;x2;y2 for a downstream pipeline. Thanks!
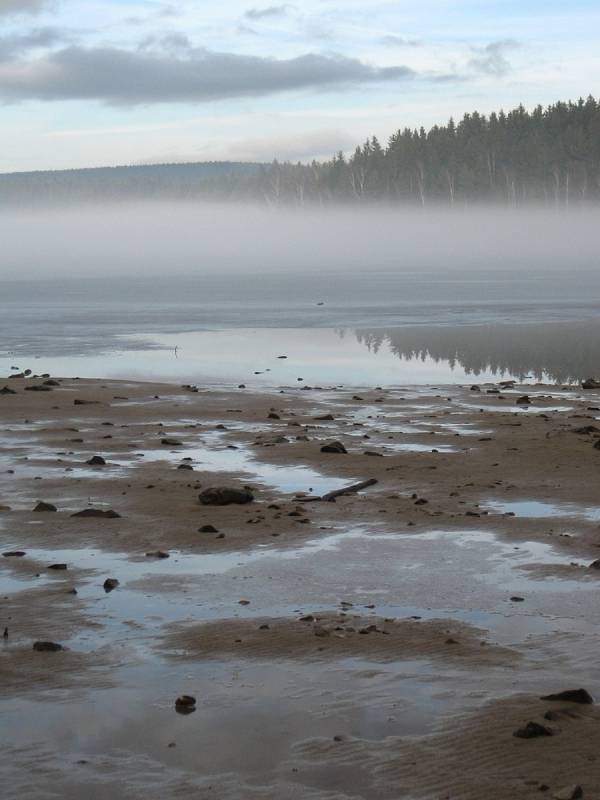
0;270;600;387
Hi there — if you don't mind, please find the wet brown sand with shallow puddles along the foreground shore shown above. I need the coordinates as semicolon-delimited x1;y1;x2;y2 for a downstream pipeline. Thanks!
0;378;600;800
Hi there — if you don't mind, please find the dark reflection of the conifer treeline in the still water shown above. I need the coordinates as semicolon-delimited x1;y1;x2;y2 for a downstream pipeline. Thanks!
356;320;600;383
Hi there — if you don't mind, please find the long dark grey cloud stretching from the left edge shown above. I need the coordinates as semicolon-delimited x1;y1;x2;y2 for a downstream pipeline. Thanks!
0;45;415;105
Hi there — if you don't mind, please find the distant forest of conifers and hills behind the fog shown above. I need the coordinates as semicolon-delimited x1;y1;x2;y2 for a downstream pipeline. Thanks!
0;96;600;207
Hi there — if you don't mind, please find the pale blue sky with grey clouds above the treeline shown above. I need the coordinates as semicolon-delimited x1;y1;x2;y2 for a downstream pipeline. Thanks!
0;0;600;172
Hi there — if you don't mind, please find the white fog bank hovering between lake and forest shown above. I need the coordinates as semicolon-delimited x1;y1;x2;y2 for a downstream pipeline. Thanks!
0;203;600;280
